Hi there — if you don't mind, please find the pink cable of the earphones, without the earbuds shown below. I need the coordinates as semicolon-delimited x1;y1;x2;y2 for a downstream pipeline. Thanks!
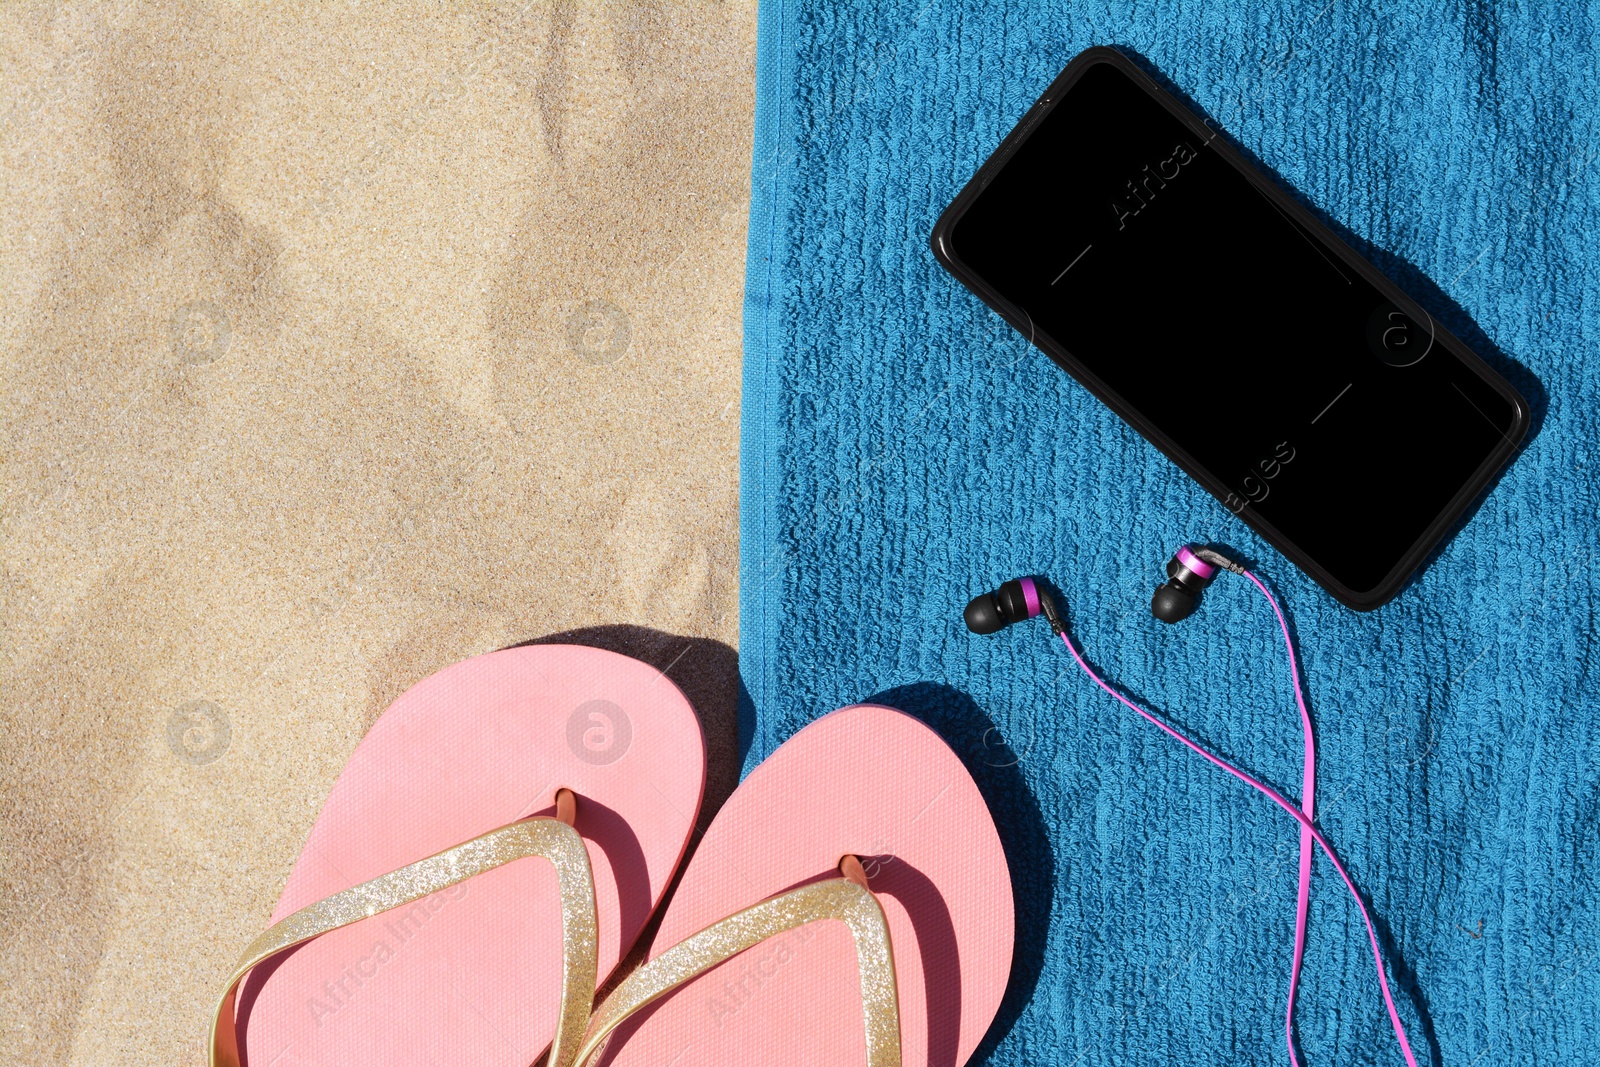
1061;568;1418;1067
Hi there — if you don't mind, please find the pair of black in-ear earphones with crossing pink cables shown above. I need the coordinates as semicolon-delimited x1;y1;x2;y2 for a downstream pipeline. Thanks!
965;545;1416;1067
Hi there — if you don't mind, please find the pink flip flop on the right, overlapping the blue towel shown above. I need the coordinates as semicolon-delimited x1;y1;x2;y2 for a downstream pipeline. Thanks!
578;705;1014;1067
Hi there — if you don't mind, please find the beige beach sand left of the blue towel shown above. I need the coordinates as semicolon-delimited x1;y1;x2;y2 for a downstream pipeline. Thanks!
0;0;755;1064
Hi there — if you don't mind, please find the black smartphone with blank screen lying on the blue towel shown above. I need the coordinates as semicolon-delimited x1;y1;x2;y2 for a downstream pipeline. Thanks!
933;48;1528;609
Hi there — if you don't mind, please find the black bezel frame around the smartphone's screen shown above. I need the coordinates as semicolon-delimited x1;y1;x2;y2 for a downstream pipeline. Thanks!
930;45;1530;611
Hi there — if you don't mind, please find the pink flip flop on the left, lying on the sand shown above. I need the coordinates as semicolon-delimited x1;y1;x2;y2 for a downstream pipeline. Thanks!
210;645;706;1067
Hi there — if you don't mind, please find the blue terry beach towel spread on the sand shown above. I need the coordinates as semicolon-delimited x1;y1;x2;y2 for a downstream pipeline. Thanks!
741;0;1600;1067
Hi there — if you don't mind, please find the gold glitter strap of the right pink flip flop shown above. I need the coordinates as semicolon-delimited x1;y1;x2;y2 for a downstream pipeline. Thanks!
576;878;899;1067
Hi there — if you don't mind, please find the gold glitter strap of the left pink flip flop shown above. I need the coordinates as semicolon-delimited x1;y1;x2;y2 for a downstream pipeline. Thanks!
210;816;598;1067
